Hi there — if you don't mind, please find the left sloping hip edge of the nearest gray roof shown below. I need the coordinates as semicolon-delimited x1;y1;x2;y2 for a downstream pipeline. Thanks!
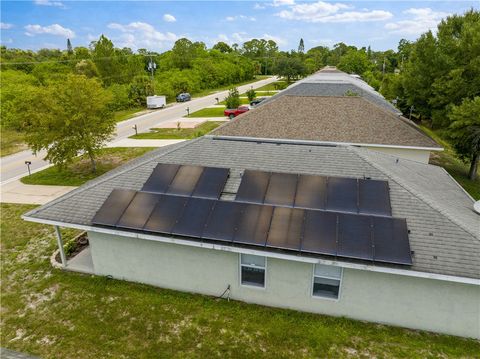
24;138;201;217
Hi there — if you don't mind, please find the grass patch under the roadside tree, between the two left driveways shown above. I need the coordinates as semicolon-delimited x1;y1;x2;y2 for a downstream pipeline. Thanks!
21;147;155;186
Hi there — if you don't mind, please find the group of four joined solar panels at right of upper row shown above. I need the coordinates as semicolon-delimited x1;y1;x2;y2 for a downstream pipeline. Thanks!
236;170;392;216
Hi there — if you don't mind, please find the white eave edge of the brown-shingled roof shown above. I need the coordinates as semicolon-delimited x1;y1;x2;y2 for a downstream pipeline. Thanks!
208;135;444;151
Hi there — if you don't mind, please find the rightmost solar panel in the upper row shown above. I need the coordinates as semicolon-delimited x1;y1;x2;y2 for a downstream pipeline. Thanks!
358;179;392;216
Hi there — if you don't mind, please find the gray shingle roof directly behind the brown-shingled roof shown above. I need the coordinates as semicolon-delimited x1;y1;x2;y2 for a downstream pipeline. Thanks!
258;82;402;115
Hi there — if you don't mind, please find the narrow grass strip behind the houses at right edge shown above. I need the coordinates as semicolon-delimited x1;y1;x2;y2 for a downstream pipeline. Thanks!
420;126;480;200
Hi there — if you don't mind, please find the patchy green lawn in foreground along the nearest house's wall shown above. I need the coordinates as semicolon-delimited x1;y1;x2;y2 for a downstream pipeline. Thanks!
0;204;480;359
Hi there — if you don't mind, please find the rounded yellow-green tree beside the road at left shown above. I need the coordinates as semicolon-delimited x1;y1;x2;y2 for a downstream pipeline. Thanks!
18;75;115;172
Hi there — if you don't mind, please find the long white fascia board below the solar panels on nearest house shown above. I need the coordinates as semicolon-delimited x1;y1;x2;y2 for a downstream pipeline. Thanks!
22;216;480;286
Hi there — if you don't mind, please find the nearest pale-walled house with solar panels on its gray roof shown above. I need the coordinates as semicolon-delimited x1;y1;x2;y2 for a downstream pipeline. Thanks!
23;138;480;338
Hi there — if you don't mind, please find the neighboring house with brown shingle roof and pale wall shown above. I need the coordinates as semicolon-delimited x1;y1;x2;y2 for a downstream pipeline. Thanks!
212;95;442;163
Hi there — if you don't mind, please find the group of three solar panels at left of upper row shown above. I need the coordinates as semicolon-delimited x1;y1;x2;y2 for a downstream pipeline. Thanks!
142;163;229;199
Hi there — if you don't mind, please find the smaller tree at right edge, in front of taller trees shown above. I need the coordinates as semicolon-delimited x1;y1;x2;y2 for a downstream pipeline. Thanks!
448;96;480;181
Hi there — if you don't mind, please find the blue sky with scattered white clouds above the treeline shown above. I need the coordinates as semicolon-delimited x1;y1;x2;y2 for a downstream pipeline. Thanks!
1;0;480;51
